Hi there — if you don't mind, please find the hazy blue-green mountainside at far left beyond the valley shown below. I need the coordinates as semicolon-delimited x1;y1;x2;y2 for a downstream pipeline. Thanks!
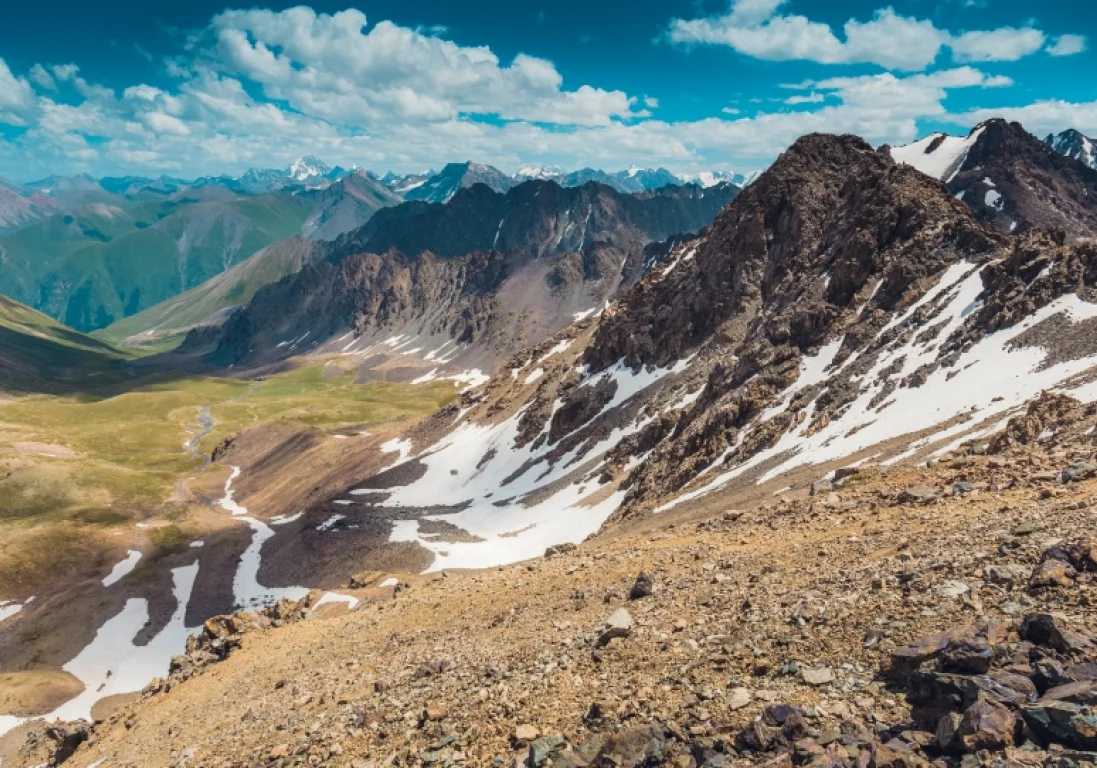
0;194;310;331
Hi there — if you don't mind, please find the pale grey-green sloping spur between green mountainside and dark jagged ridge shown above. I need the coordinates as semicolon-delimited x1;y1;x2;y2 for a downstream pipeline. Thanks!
94;237;319;351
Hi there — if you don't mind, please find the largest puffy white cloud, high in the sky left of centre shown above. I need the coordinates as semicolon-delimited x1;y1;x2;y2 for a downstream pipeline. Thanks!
212;7;642;127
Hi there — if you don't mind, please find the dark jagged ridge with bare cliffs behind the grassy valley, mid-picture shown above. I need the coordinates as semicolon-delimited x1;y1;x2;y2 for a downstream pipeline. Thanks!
190;181;736;379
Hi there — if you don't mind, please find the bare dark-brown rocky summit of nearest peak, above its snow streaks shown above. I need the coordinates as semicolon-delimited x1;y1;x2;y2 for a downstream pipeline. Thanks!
585;134;999;371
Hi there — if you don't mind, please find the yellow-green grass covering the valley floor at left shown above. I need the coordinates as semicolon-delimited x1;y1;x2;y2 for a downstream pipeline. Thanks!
0;346;455;596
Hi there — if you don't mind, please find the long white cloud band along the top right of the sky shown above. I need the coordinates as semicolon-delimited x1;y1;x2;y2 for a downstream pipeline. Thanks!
666;0;1070;71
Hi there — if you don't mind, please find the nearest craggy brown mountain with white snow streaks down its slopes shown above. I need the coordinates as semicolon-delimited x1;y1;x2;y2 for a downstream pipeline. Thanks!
329;135;1097;567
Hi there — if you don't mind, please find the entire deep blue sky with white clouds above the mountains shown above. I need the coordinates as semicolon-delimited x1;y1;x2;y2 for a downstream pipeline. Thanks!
0;0;1097;180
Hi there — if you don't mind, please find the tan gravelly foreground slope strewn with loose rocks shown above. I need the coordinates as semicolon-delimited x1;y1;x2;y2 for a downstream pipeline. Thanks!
12;399;1097;768
